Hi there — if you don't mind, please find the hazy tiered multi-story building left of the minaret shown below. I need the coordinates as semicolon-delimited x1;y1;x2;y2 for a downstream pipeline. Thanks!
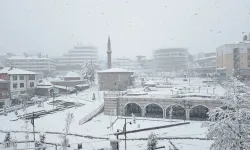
55;46;98;74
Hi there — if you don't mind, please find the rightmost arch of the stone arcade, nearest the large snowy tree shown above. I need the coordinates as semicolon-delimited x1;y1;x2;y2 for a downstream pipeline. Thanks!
189;105;209;121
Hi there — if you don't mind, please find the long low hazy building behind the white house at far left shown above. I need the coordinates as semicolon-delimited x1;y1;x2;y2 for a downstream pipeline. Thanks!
6;56;56;73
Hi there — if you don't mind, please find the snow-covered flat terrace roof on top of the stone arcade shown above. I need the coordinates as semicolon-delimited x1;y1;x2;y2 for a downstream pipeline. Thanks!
110;78;225;100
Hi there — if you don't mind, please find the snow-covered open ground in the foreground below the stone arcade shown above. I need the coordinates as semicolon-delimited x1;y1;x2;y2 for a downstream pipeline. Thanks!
0;81;215;150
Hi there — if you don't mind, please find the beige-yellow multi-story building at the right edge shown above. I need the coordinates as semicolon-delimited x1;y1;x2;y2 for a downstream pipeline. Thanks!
216;41;250;76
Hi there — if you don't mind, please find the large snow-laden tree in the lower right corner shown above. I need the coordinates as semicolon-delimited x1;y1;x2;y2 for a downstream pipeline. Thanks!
203;78;250;150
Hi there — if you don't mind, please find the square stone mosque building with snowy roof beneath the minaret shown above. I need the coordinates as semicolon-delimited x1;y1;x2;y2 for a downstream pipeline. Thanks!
98;68;133;91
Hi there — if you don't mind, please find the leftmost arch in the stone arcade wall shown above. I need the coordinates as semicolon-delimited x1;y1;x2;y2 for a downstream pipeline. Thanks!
124;102;142;117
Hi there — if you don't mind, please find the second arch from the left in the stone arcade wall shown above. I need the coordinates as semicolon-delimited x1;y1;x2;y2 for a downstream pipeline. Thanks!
144;103;164;118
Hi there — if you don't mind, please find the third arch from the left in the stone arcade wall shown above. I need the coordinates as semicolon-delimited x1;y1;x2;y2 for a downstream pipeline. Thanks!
166;104;186;119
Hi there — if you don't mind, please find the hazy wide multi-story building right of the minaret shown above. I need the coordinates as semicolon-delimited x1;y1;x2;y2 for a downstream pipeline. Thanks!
153;48;188;72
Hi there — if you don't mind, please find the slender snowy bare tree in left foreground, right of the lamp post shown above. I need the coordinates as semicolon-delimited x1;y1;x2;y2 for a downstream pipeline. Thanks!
60;113;74;150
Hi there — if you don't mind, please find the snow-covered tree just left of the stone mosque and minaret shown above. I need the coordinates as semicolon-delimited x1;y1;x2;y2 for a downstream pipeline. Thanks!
81;62;95;82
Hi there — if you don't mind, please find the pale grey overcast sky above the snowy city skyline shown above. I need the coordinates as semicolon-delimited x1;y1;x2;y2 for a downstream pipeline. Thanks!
0;0;250;58
